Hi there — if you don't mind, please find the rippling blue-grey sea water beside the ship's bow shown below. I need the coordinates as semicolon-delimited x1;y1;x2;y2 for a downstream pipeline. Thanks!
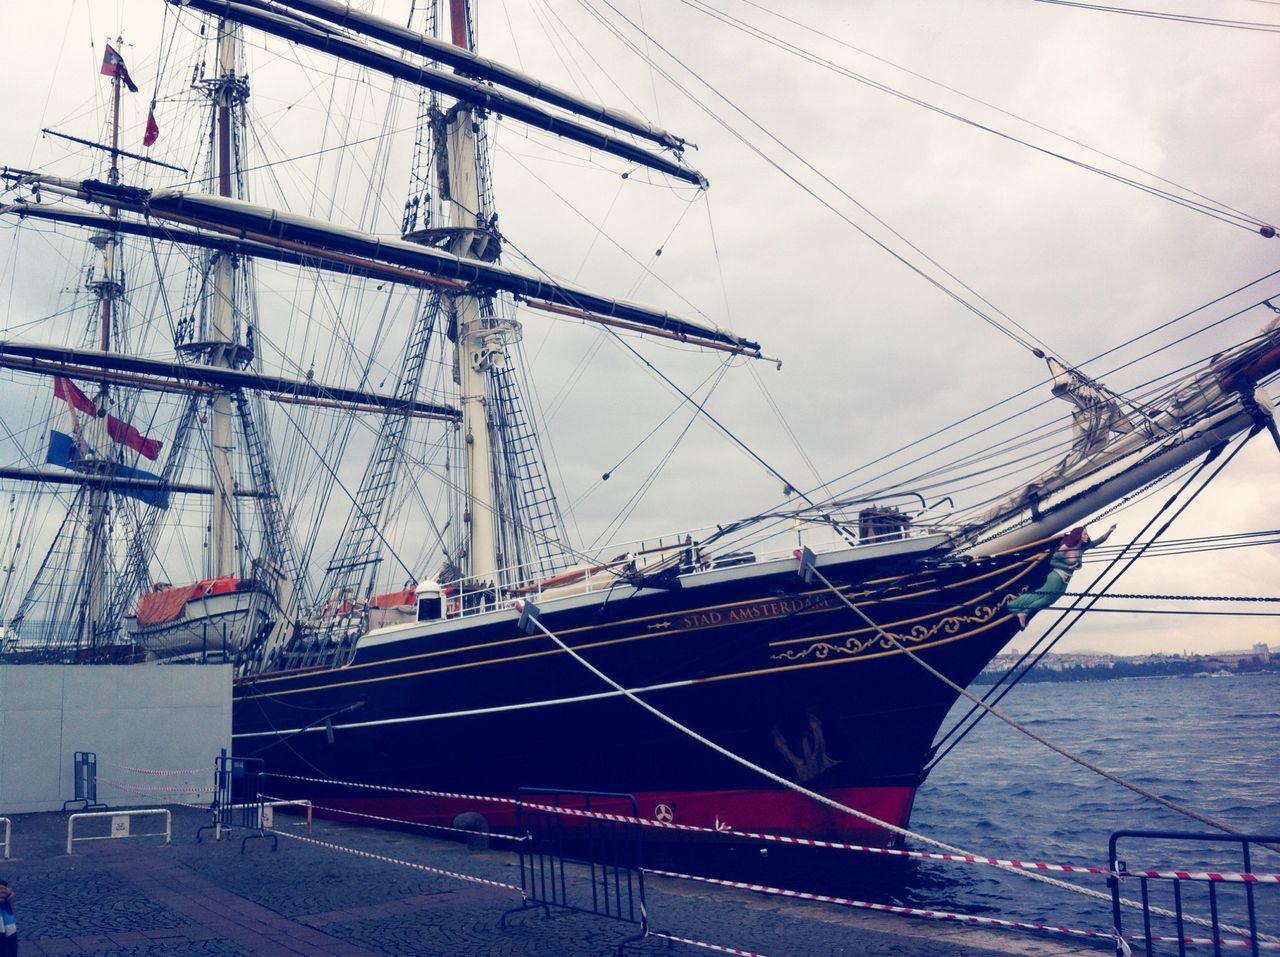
732;674;1280;953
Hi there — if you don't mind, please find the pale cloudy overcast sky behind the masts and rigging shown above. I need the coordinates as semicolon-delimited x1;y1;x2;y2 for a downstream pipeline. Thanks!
0;0;1280;654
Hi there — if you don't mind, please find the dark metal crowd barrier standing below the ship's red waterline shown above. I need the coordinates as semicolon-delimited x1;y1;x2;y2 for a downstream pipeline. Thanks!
499;788;649;957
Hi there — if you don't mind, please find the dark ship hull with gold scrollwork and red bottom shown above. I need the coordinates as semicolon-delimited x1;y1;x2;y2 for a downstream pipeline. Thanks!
234;544;1050;843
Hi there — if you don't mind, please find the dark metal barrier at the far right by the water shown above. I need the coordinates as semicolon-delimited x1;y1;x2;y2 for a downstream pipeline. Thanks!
1107;830;1280;957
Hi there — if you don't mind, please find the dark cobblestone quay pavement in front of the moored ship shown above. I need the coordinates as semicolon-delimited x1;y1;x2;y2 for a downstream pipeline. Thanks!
0;807;1107;957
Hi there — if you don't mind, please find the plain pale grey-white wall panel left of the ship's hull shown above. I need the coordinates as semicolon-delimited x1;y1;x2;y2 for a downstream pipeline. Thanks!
0;664;232;815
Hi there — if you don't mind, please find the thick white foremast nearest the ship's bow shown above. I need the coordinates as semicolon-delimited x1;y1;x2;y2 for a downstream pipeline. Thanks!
442;0;506;582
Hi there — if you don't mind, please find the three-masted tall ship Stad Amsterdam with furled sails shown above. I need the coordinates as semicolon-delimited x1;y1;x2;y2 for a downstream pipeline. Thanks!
0;0;1280;843
